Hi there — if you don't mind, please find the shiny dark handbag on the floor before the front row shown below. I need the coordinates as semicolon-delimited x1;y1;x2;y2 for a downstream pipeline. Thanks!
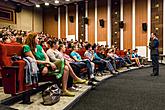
42;84;61;105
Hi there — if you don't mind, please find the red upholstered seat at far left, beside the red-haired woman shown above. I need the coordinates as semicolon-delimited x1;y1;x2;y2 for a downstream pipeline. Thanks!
0;43;29;94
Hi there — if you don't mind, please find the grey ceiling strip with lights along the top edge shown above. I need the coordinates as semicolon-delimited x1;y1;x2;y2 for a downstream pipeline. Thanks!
11;0;83;6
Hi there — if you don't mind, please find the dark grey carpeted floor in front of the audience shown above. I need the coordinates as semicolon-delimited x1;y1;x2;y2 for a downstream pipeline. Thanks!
71;65;165;110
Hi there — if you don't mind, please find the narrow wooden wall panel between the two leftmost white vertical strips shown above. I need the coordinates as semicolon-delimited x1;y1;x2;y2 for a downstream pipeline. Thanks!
60;6;66;38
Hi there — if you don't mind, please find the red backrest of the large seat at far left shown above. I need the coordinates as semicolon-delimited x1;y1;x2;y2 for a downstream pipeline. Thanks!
0;43;23;66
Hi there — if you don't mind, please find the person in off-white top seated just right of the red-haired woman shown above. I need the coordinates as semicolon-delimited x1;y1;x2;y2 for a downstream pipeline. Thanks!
46;41;86;88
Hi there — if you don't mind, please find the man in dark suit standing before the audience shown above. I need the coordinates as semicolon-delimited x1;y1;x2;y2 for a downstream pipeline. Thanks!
149;33;159;76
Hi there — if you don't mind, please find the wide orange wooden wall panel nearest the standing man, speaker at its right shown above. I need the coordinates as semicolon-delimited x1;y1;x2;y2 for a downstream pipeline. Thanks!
135;0;147;46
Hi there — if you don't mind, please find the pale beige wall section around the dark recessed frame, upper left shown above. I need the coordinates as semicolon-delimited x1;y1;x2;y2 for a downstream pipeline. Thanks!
0;0;43;32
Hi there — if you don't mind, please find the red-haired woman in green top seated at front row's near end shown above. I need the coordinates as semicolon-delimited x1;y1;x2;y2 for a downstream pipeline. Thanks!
23;33;74;96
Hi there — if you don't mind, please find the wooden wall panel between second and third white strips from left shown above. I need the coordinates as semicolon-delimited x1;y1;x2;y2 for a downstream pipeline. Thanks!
68;4;76;36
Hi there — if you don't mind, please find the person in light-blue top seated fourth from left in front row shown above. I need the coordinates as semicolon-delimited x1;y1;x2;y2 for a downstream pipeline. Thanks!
70;46;98;85
